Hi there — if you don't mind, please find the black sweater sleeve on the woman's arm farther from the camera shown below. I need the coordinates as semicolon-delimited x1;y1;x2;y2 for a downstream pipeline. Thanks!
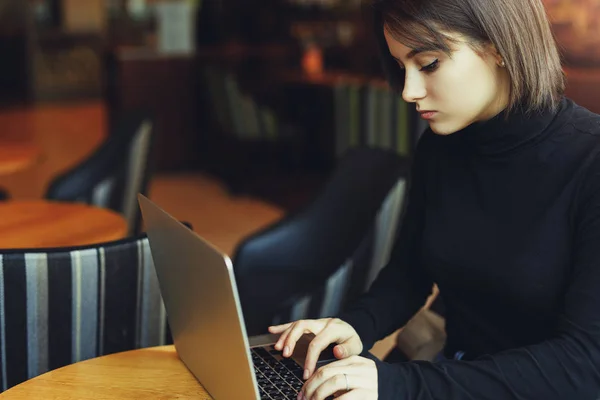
340;131;433;349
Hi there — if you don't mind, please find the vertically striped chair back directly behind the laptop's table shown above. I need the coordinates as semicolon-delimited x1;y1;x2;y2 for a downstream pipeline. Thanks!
0;235;172;391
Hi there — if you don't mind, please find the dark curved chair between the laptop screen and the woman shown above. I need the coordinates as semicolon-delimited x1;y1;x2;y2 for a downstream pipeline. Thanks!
233;148;408;335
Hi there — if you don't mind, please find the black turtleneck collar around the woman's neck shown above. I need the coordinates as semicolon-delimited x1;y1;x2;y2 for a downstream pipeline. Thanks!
436;97;568;155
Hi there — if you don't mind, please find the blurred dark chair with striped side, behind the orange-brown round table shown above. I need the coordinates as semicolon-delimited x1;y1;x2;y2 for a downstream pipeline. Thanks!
45;111;154;234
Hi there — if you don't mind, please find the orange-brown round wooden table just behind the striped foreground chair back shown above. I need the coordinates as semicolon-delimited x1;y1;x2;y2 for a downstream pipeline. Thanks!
0;200;127;249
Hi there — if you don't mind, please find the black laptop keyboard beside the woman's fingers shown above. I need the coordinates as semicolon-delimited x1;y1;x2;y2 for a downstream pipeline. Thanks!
251;346;304;400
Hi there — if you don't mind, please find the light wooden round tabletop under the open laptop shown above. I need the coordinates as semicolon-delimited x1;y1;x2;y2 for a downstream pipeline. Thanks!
1;346;212;400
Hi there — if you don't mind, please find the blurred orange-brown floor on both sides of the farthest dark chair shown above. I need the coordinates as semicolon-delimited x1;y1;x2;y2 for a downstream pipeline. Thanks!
0;103;283;254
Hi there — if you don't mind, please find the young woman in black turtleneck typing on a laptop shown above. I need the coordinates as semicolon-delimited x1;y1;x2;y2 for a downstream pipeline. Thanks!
270;0;600;400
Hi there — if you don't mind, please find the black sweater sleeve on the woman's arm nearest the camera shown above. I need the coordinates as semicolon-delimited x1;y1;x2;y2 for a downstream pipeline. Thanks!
377;155;600;400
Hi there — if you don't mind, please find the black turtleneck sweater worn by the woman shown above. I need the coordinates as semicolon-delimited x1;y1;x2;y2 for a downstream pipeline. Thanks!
341;99;600;400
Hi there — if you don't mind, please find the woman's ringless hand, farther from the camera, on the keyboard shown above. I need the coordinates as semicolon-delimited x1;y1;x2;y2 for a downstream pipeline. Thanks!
269;318;363;380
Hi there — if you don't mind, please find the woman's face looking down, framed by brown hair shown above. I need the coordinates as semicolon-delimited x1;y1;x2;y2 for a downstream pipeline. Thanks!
384;29;510;135
